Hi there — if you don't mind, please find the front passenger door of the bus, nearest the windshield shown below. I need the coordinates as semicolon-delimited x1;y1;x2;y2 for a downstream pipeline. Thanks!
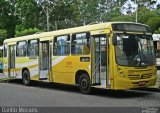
92;35;110;87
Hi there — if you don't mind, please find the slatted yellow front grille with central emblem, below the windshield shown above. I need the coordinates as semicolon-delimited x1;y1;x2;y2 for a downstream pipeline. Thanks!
128;73;152;80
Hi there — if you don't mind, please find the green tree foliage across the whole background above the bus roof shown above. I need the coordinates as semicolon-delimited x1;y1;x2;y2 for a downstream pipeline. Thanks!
0;0;160;38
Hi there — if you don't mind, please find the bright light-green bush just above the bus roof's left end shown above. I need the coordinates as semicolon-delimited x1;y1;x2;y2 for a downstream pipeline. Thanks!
16;28;41;37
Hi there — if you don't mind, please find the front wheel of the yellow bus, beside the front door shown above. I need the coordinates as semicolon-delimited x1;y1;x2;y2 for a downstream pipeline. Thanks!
79;73;91;94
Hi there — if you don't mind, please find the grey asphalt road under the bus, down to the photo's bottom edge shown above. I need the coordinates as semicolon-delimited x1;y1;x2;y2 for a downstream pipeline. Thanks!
0;71;160;113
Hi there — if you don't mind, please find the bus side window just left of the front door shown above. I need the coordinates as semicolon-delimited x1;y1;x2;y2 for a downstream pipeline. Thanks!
72;33;90;55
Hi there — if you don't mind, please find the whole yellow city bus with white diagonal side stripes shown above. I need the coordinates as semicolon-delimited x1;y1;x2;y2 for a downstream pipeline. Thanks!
3;22;157;94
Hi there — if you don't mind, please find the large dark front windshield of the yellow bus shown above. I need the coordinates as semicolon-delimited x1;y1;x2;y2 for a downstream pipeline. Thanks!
115;33;155;67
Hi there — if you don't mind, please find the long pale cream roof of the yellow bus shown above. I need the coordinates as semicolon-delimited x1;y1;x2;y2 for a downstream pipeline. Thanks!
4;22;148;43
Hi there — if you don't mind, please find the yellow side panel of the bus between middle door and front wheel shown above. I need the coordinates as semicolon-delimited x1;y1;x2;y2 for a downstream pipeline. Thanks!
52;55;91;84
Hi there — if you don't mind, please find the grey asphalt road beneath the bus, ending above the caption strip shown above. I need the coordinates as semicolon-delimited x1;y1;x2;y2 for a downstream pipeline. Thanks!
0;80;160;107
